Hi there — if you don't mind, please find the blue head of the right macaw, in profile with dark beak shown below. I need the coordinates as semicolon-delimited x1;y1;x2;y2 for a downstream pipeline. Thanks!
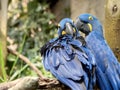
74;14;102;35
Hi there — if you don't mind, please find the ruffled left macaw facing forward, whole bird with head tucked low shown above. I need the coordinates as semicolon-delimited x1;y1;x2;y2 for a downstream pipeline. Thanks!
41;18;96;90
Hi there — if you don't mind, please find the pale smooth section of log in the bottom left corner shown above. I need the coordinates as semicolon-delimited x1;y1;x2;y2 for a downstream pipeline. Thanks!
0;76;39;90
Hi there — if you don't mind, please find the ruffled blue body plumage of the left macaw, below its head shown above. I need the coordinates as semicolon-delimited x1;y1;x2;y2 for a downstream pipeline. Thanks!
41;35;95;90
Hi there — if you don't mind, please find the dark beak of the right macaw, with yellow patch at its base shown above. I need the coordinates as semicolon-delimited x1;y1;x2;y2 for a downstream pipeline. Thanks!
74;18;92;35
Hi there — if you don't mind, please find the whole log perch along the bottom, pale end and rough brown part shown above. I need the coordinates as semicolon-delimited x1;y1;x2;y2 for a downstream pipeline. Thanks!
0;76;70;90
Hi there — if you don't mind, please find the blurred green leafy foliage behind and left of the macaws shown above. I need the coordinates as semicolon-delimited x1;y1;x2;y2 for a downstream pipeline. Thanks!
7;0;57;80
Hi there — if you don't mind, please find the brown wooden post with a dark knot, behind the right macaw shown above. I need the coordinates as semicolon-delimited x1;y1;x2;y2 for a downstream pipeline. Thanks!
104;0;120;60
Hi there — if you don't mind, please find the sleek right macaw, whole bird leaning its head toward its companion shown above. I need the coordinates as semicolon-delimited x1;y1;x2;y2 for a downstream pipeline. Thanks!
75;14;120;90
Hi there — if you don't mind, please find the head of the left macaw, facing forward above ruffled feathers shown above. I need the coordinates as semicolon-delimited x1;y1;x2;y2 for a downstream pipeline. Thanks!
58;18;79;36
